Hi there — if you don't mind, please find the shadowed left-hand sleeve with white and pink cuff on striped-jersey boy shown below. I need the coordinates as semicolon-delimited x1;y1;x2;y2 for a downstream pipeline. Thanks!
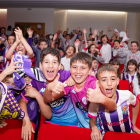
88;103;99;119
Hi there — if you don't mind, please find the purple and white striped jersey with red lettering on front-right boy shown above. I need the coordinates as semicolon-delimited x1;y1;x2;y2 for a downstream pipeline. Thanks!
88;90;137;135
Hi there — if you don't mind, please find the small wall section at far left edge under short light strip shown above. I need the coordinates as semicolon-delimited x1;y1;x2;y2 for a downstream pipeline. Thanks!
0;9;7;29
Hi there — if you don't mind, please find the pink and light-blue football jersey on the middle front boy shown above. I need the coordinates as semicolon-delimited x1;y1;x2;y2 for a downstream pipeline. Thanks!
64;76;100;128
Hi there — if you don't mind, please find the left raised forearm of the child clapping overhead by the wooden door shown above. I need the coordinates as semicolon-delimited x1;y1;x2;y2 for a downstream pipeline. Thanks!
5;35;20;60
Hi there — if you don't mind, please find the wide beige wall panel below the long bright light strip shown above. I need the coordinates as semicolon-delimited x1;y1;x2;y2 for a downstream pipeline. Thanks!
66;10;127;37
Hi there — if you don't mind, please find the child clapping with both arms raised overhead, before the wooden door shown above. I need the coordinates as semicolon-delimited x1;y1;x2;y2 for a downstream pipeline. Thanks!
5;27;33;59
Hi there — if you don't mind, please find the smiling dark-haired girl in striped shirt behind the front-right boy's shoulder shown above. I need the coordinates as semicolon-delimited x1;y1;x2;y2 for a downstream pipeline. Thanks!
122;59;137;90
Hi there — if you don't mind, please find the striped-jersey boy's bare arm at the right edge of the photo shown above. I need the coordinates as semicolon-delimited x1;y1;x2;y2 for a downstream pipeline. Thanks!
132;99;140;134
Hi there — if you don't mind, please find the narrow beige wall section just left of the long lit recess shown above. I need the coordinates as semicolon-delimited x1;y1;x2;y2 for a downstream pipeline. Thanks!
54;9;67;33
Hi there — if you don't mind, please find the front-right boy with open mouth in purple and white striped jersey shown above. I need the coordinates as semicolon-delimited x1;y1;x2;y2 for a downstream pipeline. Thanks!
87;64;140;140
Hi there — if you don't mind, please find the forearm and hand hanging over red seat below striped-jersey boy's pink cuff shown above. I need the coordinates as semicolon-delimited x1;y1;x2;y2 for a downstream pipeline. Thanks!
89;118;102;140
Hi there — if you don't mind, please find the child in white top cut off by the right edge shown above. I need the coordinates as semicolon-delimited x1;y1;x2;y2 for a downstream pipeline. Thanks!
133;63;140;99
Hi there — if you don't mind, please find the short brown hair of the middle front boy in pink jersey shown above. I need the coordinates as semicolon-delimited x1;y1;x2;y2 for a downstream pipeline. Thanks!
70;52;92;69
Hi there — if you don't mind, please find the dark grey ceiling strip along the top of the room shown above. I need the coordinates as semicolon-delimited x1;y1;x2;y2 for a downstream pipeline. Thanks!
0;0;140;12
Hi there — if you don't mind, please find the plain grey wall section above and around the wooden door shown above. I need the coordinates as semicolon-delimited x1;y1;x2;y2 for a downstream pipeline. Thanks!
7;8;54;34
